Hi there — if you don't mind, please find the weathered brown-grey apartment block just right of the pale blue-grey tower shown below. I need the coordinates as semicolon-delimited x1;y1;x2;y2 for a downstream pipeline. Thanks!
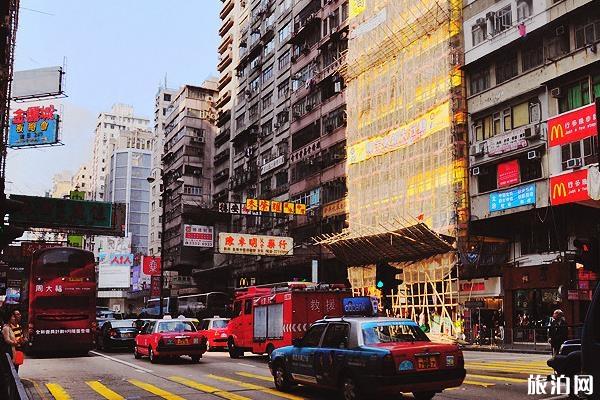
162;80;218;276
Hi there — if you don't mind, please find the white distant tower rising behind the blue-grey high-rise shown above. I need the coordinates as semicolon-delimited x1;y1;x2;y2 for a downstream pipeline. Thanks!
90;104;150;201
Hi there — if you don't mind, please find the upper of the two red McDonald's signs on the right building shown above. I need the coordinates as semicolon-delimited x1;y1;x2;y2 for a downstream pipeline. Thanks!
548;103;598;147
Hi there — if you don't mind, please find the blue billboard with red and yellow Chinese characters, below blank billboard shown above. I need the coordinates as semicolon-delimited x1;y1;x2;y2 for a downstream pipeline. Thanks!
8;105;59;148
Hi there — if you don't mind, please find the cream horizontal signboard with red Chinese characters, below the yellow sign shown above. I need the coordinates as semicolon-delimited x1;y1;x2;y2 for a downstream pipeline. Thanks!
219;232;294;256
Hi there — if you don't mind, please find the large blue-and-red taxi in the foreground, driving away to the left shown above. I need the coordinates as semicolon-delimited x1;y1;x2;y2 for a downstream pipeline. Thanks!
269;317;466;400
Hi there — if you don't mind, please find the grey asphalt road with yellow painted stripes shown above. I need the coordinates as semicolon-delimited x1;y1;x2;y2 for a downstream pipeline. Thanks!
20;352;555;400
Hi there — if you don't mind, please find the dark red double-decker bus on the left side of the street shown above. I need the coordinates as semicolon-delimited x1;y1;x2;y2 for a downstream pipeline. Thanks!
28;247;96;354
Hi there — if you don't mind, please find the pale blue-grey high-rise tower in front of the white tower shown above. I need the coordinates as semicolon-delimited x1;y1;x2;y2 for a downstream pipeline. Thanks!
104;129;153;255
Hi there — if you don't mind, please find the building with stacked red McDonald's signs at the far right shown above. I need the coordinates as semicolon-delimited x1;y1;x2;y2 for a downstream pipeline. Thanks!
461;0;600;342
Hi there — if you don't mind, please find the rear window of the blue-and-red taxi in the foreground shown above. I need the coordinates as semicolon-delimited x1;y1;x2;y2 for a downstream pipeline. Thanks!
362;321;429;345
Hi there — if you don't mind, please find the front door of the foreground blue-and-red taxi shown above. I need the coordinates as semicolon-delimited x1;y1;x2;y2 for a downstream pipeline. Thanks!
289;324;327;385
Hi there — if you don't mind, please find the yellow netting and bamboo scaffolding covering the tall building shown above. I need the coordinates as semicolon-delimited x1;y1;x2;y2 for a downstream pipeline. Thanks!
322;0;468;334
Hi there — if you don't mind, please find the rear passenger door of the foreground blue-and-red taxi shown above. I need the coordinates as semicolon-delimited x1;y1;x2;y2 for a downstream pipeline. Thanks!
314;322;352;387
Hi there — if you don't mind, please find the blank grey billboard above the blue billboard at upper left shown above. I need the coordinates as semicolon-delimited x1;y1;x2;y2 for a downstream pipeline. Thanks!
11;66;64;101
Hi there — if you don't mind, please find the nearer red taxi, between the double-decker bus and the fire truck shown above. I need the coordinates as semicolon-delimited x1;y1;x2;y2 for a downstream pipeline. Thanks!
133;319;206;363
